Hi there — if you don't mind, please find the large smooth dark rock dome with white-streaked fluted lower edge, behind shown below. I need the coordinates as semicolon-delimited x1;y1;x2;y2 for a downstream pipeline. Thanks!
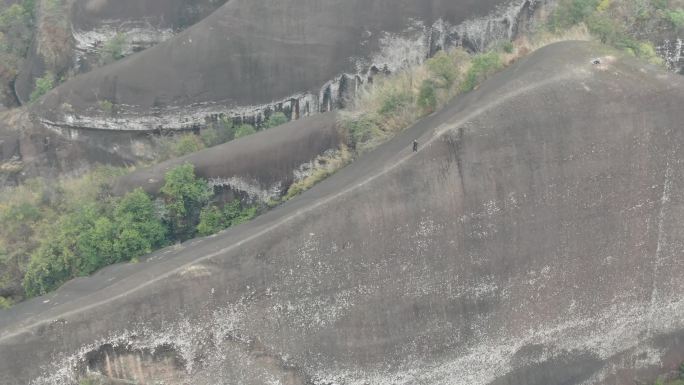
33;0;546;131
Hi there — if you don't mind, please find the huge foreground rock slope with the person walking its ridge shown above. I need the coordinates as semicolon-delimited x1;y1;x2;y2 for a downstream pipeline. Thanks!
0;43;684;385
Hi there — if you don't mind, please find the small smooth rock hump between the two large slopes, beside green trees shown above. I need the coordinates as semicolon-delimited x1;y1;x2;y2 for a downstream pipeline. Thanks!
114;112;344;202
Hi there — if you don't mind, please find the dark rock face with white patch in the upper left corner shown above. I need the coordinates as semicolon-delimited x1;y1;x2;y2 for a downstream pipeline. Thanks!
15;0;226;103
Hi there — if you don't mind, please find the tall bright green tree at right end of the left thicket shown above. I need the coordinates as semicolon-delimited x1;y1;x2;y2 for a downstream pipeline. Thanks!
161;163;213;241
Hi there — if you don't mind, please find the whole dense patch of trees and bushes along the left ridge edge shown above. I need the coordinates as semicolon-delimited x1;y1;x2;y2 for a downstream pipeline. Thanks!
0;164;258;298
